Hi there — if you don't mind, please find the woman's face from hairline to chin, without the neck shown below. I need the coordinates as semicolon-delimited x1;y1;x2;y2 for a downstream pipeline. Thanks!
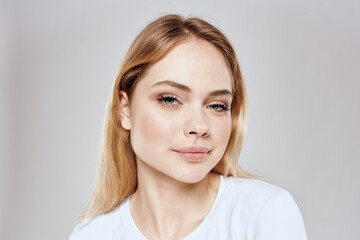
123;40;232;183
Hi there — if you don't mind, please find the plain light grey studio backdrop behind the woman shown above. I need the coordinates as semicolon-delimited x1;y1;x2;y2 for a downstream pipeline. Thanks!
0;0;360;240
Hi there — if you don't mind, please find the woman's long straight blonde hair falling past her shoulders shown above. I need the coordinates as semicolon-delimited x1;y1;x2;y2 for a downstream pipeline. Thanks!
83;15;253;219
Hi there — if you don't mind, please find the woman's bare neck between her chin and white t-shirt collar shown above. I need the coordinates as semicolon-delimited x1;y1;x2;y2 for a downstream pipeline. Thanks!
130;161;219;239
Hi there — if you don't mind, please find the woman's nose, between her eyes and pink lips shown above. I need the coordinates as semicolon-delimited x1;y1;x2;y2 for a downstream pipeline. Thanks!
184;110;210;137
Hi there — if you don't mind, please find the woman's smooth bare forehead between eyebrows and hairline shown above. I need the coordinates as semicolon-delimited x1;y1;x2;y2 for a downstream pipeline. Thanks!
138;39;232;91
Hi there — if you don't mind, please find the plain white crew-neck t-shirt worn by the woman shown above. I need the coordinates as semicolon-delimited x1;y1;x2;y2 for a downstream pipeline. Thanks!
70;176;307;240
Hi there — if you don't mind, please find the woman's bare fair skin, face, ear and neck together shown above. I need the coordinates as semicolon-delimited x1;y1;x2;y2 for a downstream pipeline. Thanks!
120;39;232;239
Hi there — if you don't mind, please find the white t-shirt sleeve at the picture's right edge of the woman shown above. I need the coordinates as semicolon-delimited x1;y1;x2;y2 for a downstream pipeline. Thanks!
256;190;307;240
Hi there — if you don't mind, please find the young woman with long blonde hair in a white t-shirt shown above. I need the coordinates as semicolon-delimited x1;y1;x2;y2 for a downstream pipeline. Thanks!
70;15;306;240
